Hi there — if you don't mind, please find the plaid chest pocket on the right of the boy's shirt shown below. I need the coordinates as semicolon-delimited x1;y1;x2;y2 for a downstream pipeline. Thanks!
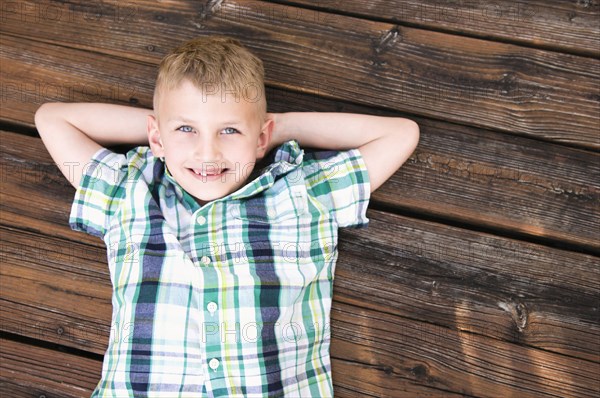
233;184;308;224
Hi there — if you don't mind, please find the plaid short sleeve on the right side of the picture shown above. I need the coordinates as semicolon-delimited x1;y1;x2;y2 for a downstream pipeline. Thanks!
303;149;371;227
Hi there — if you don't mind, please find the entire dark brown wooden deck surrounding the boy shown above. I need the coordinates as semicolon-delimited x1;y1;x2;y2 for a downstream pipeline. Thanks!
0;0;600;398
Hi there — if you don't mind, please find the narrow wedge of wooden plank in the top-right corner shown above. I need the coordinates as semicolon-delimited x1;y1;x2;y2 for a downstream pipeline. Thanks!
274;0;600;57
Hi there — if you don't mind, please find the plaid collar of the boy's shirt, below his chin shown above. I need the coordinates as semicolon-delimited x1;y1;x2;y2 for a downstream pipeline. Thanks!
163;140;304;211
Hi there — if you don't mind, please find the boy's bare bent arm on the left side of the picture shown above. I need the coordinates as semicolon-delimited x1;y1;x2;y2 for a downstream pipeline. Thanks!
35;103;153;188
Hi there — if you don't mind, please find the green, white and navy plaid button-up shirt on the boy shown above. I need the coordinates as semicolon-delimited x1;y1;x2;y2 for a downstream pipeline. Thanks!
70;141;370;398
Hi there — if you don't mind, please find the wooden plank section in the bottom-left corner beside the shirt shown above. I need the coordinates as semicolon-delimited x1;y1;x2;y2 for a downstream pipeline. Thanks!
0;339;102;398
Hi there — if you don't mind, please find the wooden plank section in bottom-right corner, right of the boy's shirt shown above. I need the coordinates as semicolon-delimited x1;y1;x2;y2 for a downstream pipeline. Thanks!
332;302;600;398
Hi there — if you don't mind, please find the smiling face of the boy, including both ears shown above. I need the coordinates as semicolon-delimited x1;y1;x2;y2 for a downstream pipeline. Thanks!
148;80;273;205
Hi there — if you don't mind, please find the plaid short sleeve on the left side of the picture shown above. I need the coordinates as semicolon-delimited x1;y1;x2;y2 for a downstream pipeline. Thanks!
69;148;127;238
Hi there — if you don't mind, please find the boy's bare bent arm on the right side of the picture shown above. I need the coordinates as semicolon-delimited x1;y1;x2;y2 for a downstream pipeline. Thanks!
269;112;419;192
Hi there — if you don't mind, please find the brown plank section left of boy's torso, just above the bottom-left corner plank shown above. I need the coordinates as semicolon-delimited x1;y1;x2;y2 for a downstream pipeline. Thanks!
0;228;112;353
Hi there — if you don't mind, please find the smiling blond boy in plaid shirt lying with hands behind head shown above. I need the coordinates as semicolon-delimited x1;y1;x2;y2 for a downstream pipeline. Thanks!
36;37;419;398
